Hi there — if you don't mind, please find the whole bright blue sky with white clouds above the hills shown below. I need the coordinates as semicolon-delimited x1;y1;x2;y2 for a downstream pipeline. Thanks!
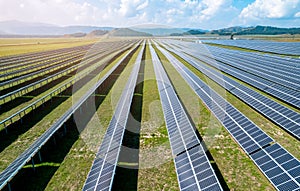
0;0;300;30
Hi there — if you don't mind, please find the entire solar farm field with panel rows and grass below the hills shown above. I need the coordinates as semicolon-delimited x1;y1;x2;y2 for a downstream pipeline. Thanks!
0;37;300;191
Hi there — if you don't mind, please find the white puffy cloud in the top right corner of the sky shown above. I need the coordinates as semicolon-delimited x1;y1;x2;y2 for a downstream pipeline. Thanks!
239;0;300;20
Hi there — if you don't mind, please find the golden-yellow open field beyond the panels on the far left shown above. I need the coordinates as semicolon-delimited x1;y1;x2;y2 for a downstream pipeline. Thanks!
0;38;99;57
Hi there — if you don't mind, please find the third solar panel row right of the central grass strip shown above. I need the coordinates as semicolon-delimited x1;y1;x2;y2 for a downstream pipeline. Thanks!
161;40;300;139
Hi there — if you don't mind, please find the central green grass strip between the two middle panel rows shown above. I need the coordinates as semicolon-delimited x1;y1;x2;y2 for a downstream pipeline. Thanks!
138;45;179;190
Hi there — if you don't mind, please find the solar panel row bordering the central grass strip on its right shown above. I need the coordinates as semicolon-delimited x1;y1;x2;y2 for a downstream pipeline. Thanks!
150;41;222;191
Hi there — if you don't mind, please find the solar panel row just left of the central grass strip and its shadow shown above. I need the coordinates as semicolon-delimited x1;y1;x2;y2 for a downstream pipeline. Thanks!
83;42;145;191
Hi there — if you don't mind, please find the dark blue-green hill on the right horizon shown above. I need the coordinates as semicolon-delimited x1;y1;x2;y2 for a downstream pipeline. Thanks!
210;26;300;35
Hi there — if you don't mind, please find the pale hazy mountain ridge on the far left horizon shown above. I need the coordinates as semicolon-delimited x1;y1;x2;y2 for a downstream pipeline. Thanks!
0;20;113;35
